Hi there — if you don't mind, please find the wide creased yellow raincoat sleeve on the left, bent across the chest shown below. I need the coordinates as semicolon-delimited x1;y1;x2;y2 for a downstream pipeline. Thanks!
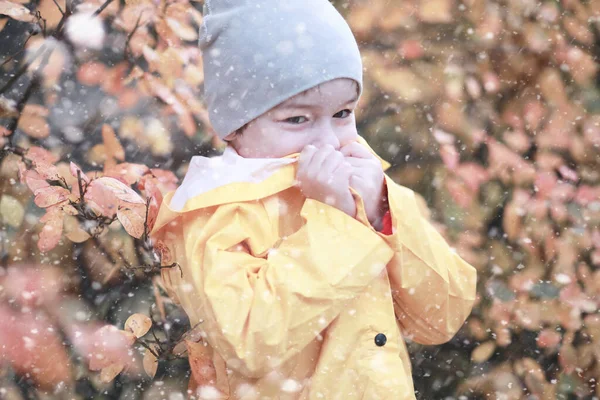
185;199;392;377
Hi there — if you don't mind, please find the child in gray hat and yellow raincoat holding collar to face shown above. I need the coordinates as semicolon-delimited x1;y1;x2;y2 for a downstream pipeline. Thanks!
152;0;476;400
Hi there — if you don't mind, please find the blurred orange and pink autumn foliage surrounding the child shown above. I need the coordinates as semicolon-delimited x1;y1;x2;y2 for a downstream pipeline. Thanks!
0;0;600;400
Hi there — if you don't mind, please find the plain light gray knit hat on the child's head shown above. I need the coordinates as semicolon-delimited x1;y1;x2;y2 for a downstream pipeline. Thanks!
200;0;362;138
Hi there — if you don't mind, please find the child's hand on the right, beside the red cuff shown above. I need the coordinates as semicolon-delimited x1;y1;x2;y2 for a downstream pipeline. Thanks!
340;142;386;230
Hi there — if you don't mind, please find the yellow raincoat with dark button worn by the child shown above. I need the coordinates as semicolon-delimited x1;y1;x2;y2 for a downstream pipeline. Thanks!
152;141;476;400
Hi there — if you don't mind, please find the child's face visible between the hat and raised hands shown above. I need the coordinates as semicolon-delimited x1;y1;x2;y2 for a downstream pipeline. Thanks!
228;79;358;158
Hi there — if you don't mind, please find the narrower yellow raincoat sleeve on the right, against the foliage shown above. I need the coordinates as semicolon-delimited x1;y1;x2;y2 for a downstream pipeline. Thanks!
380;176;477;345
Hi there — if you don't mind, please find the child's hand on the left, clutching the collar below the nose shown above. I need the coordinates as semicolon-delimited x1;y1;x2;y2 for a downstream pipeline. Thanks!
296;145;356;218
